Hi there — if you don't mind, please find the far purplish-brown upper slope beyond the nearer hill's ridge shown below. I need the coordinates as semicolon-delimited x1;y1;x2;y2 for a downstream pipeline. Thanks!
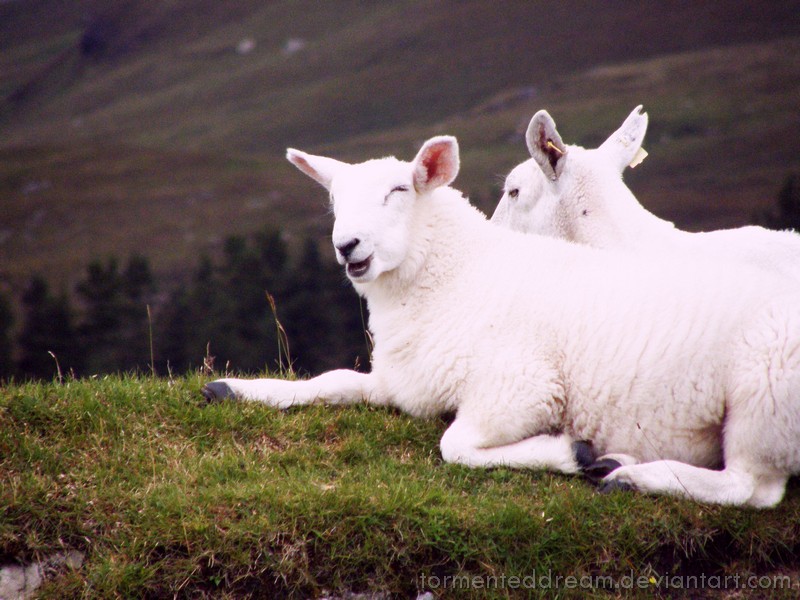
0;1;800;151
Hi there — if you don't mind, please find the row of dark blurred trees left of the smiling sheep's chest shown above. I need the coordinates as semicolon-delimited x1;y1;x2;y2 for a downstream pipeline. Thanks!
0;231;369;379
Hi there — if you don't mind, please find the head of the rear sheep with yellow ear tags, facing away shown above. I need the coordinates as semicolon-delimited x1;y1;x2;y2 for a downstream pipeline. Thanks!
492;106;647;245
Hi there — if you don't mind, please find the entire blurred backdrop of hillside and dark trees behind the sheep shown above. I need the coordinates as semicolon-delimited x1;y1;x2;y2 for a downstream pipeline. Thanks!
0;0;800;379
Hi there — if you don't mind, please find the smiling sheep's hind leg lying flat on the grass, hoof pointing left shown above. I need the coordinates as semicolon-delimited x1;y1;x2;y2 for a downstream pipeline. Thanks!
602;460;788;508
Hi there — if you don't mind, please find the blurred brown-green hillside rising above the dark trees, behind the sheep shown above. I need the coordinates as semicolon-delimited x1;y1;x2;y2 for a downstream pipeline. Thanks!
0;0;800;289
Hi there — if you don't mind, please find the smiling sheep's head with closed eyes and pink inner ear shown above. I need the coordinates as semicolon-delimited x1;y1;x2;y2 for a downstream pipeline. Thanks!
286;136;459;284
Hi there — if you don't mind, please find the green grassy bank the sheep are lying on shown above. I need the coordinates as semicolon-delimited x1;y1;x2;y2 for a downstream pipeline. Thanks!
0;375;800;598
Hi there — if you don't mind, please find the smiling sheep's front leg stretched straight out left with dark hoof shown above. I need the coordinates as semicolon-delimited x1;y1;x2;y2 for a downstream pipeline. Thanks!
202;369;380;408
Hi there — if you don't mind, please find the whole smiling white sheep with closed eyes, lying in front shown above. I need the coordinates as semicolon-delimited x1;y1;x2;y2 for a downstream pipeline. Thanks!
203;137;800;507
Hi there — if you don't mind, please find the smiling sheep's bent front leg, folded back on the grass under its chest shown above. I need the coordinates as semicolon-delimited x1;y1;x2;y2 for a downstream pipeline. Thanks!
440;418;579;473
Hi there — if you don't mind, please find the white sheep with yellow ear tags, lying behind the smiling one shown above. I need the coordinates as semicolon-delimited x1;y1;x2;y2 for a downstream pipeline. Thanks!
492;106;800;282
